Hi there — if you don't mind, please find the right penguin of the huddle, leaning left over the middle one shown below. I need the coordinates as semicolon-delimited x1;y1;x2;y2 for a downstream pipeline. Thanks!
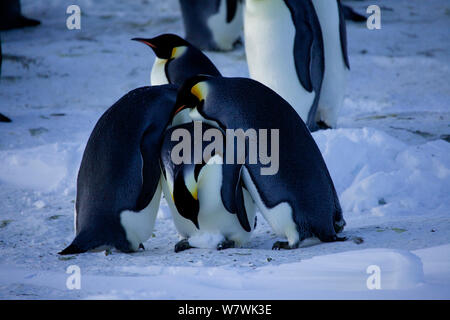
174;76;346;249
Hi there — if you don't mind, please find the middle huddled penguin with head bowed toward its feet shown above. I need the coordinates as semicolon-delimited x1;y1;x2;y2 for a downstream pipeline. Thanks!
161;121;256;252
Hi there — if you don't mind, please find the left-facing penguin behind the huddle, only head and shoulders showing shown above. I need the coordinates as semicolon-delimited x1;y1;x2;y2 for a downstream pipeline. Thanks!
132;34;220;86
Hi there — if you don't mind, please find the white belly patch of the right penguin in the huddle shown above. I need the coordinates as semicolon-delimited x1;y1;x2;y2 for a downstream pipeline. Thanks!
243;167;300;245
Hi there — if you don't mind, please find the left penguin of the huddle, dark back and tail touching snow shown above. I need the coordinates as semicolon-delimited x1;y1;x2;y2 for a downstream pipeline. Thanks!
60;85;177;255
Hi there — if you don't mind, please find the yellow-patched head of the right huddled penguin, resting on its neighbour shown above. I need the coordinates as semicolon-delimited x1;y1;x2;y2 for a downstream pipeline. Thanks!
172;74;213;117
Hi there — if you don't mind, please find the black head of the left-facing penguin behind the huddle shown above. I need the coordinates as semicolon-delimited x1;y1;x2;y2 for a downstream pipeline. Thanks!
131;33;190;60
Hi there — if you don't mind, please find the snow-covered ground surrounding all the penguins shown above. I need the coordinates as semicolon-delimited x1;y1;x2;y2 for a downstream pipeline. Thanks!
0;0;450;299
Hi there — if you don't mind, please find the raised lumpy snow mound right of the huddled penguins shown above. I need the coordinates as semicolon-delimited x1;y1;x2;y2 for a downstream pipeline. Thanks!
314;128;450;216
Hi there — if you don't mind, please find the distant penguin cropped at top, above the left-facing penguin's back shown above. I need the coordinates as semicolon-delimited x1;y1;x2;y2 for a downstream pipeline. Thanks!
180;0;244;51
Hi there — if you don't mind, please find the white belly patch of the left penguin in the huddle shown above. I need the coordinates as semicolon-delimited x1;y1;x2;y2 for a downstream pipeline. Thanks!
120;182;161;251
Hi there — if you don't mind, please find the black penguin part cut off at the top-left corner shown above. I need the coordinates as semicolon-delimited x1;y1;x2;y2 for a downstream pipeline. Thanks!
0;0;40;30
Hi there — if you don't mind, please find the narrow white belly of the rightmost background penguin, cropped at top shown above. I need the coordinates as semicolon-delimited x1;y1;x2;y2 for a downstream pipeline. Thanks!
313;0;349;128
